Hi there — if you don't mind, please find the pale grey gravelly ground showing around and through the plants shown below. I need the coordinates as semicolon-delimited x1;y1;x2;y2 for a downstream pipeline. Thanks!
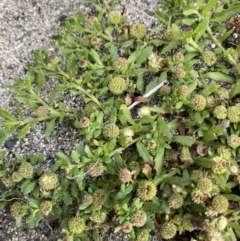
0;0;162;241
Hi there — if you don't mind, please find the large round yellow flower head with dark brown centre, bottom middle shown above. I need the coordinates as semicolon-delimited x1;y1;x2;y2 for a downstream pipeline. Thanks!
137;181;157;201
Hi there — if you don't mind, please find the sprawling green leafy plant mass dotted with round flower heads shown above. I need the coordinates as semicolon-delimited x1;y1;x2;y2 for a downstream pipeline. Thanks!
0;0;240;241
